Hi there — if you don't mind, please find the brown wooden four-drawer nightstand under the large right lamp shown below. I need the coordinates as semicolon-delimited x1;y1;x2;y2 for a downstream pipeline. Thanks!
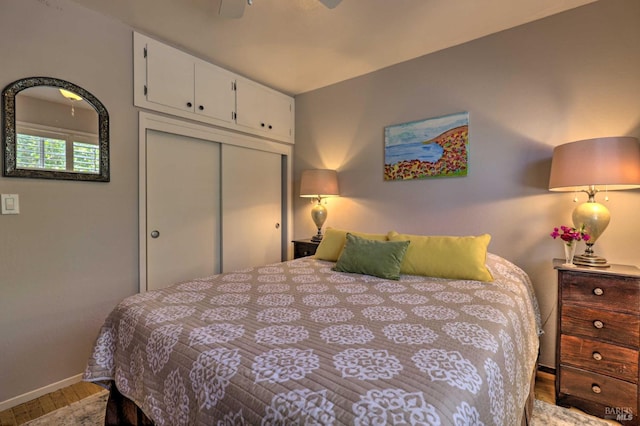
554;260;640;425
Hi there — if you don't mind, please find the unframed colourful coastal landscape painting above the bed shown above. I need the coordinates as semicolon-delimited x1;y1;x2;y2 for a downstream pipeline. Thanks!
384;112;469;180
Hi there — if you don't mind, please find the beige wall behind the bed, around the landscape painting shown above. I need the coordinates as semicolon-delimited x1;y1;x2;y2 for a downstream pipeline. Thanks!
294;0;640;366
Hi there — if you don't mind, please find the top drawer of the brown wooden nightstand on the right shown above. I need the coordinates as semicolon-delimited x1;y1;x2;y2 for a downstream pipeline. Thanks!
560;271;640;314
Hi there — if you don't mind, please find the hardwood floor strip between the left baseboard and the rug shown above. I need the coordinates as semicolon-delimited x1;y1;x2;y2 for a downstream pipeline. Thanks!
0;382;104;426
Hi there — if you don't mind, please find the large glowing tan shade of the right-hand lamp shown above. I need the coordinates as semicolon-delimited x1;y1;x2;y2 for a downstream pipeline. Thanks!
549;137;640;191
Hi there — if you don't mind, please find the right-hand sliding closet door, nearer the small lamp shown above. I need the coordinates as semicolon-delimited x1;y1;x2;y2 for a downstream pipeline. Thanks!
222;145;283;272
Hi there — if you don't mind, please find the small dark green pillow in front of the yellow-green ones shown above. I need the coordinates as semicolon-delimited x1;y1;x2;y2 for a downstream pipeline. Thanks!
333;233;409;280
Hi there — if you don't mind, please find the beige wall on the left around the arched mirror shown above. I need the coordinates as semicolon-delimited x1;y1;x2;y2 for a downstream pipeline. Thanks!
0;0;138;403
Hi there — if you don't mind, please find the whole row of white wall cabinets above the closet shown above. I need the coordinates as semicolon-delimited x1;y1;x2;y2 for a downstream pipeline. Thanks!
133;32;294;143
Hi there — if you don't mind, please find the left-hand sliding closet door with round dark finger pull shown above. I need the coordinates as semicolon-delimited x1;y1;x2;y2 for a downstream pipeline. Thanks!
146;130;220;290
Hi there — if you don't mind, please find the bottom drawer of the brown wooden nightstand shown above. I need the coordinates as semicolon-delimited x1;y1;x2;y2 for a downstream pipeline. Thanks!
559;365;638;416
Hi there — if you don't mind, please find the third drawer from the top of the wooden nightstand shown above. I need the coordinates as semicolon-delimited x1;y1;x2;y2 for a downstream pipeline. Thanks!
560;335;638;384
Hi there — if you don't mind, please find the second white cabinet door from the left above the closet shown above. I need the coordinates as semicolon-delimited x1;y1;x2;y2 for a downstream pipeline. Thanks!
195;62;236;123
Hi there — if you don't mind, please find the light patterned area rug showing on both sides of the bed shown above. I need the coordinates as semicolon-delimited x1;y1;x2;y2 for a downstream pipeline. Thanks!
25;391;615;426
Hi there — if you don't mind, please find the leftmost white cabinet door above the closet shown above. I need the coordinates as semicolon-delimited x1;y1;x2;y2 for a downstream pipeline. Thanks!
147;40;194;112
